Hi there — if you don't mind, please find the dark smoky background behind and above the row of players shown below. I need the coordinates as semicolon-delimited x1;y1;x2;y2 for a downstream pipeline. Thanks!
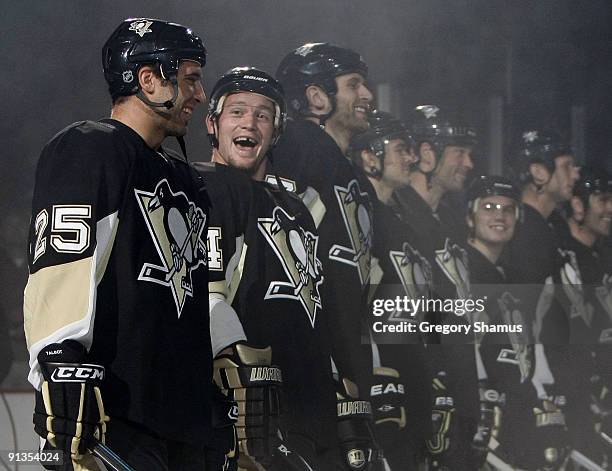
0;0;612;366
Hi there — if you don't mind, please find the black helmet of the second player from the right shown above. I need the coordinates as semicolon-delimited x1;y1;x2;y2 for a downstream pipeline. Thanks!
510;129;573;184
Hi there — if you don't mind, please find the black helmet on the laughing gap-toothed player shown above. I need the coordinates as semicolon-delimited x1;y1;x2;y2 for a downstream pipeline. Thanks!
208;67;287;147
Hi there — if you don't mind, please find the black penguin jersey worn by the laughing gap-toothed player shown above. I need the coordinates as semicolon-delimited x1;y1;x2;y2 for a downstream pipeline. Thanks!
195;164;336;448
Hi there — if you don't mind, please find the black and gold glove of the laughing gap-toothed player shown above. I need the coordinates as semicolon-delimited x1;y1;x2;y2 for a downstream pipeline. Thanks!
214;344;283;469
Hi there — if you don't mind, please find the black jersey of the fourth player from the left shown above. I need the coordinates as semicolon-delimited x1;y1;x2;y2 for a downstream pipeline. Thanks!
369;200;432;469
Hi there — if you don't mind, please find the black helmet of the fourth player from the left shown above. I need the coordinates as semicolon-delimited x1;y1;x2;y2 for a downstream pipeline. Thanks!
350;110;415;161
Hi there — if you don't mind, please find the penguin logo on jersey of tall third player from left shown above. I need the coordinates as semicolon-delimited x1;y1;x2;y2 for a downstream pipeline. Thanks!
329;180;372;285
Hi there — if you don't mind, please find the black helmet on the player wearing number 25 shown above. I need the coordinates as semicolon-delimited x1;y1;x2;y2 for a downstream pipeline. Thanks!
102;18;206;108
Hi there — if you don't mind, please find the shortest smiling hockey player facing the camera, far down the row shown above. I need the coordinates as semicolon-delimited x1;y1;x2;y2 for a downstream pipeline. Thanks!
466;176;544;469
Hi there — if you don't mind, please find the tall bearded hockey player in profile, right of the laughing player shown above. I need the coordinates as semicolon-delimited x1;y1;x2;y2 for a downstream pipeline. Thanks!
266;43;378;469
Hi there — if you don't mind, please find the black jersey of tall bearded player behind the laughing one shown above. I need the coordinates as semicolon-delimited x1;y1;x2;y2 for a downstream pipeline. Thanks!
266;120;373;388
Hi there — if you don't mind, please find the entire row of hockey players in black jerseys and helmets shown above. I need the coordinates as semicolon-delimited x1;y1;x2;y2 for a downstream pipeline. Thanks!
24;19;612;471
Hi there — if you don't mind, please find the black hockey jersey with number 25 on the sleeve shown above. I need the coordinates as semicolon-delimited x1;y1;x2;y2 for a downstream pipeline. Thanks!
24;119;212;442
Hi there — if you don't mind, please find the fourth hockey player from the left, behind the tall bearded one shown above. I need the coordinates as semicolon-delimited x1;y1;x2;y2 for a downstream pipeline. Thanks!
351;111;432;469
